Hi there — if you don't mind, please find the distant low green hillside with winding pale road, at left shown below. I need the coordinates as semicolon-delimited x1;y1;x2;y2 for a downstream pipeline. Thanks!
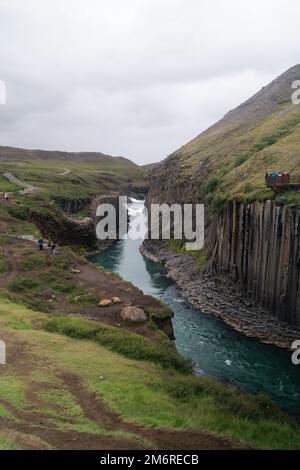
0;147;147;199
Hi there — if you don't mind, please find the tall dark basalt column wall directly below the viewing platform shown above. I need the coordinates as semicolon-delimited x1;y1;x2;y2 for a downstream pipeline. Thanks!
206;201;300;325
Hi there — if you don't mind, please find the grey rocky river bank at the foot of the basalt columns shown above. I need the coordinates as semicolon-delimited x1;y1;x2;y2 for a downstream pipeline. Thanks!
140;240;300;350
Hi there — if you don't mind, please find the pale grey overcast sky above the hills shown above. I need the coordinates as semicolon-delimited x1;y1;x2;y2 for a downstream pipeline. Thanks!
0;0;300;163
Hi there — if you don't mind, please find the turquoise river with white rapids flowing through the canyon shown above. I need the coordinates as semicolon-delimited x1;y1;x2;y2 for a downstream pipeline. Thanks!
90;200;300;416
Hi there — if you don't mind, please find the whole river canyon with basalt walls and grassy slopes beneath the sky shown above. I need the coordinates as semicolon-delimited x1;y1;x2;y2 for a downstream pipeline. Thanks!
0;65;300;449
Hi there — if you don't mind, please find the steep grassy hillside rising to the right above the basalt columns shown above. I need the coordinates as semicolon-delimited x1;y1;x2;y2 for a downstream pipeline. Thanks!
153;65;300;209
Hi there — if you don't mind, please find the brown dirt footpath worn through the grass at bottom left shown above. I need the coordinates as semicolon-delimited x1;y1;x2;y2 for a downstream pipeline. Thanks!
0;332;244;450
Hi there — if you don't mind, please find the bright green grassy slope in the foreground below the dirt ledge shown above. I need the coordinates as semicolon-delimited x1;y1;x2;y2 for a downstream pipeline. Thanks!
0;300;300;449
